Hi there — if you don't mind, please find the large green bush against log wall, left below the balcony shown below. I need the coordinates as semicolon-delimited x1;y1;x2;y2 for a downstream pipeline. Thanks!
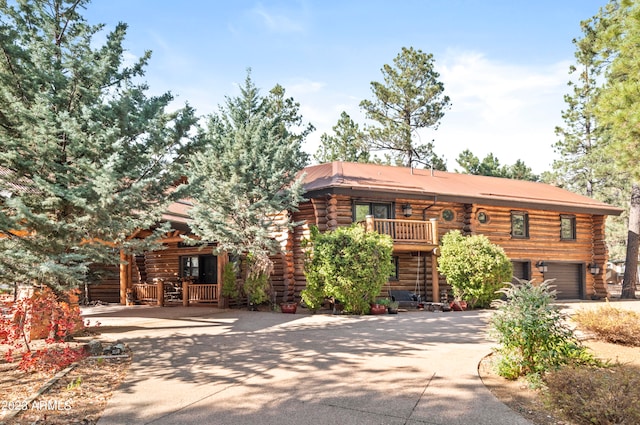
301;225;393;314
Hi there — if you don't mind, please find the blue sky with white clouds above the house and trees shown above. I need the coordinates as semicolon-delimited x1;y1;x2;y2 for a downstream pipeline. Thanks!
84;0;606;173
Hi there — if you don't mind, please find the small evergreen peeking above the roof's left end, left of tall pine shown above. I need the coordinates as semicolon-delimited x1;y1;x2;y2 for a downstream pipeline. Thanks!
314;111;370;163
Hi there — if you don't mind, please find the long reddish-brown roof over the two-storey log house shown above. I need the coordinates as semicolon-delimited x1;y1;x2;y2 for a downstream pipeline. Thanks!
303;161;623;215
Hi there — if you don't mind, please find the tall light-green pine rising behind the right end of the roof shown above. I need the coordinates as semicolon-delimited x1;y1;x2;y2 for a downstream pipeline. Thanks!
545;1;631;258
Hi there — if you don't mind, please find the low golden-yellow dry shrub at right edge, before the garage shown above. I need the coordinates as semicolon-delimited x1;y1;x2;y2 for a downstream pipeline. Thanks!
571;303;640;347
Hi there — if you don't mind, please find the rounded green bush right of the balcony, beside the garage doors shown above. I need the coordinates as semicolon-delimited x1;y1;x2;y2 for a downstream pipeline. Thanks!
438;230;513;308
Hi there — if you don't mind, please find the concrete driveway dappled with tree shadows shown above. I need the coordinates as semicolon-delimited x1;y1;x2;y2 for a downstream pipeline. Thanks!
84;307;530;425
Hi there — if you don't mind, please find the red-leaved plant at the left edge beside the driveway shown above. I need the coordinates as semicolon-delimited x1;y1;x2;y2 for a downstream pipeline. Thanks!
0;287;85;370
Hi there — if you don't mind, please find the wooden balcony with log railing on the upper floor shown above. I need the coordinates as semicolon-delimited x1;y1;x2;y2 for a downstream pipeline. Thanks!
361;216;438;252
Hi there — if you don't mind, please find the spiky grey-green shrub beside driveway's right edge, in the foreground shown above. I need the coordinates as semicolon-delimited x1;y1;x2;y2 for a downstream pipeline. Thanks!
490;280;596;379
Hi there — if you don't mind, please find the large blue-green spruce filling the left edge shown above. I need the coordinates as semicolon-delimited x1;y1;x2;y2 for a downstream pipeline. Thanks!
0;0;195;289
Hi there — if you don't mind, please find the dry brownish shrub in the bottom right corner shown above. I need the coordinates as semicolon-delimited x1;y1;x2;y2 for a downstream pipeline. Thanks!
544;365;640;425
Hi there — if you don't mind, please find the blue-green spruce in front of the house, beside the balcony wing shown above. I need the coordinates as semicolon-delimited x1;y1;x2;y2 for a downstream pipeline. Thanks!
188;75;313;276
